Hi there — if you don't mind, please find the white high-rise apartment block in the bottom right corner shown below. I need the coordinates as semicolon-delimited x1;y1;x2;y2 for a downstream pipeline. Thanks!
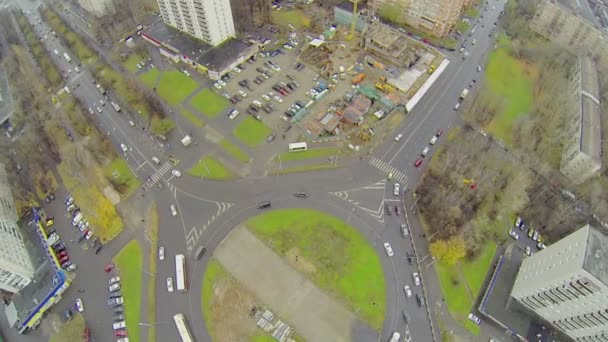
511;225;608;342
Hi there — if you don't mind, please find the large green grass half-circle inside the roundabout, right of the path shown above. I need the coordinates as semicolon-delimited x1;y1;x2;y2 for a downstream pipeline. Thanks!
246;209;386;329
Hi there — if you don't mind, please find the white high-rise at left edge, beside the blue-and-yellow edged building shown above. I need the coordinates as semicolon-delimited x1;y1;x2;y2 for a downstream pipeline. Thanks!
0;163;34;293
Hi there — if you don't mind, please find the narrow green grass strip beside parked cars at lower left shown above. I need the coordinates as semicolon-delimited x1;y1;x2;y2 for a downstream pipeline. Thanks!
114;240;144;342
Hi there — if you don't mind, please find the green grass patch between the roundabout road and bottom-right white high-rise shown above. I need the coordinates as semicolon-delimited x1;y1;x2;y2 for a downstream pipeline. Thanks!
435;242;496;335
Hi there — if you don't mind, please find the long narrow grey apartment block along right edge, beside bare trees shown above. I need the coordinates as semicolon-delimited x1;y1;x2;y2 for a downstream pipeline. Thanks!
560;57;602;184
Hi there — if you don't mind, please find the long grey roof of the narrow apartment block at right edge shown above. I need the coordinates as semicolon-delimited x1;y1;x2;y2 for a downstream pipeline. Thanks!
579;57;602;164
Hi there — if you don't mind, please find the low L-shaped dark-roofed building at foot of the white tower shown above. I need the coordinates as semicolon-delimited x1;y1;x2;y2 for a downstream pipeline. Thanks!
139;20;259;80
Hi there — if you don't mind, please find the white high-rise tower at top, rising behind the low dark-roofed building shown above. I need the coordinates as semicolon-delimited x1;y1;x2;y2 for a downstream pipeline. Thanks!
158;0;236;46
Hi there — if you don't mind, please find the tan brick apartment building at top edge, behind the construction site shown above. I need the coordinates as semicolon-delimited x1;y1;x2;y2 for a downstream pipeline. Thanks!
369;0;472;37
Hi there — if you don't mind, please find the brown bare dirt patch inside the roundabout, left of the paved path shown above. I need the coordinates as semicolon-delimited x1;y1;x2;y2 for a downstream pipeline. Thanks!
211;276;262;342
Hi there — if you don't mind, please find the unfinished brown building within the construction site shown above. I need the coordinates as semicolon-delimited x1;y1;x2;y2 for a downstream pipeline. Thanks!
364;23;416;69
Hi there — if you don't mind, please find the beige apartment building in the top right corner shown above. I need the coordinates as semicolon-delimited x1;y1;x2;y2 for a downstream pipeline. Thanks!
530;0;608;69
